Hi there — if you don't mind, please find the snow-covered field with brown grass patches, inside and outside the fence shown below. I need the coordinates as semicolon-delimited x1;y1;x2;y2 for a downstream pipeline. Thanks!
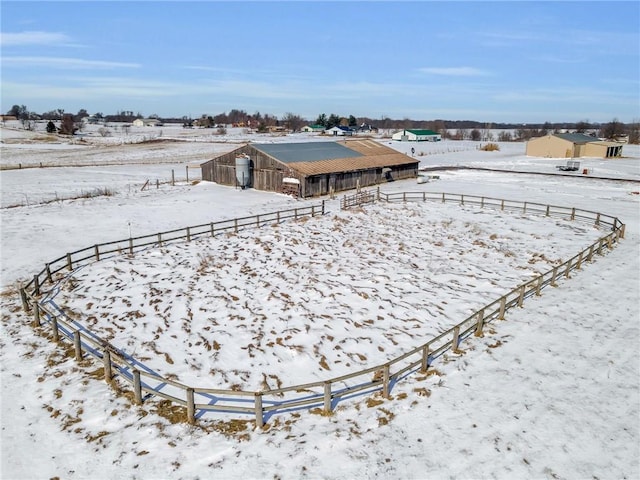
0;125;640;479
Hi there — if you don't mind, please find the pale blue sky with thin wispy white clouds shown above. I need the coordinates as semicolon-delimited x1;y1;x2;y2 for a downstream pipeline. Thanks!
0;0;640;123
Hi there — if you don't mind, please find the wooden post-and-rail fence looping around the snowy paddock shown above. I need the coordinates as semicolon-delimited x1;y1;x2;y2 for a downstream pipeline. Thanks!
20;190;625;428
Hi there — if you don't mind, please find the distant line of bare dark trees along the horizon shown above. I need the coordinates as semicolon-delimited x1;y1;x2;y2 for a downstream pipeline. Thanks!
6;105;640;143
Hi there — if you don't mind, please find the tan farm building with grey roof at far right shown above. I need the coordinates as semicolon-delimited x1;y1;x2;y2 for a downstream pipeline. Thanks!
527;133;622;158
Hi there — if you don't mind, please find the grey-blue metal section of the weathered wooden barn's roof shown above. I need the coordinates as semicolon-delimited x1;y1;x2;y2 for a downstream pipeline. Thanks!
251;142;363;163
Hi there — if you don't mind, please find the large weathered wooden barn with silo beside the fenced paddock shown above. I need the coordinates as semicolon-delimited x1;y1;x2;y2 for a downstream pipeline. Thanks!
201;140;419;197
